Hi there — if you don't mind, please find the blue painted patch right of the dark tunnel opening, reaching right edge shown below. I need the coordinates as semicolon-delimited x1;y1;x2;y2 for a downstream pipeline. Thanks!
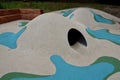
86;28;120;45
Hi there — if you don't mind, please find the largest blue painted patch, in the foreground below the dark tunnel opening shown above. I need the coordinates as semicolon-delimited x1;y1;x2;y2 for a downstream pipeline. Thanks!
12;55;114;80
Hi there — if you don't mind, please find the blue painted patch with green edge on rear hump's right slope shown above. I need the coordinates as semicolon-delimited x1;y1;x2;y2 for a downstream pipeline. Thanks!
90;10;115;24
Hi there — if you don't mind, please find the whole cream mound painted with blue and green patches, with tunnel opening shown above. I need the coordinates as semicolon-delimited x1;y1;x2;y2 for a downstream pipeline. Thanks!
0;8;120;80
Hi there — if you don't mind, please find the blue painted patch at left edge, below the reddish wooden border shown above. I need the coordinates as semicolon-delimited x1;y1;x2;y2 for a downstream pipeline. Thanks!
0;27;26;49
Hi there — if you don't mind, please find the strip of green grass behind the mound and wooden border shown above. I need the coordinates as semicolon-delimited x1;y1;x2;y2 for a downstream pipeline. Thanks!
2;1;117;12
